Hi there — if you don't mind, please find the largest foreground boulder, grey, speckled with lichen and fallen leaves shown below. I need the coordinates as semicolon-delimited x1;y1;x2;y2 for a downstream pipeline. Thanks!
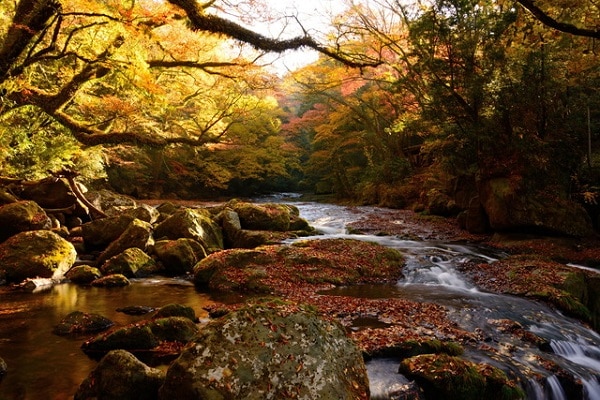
159;301;369;400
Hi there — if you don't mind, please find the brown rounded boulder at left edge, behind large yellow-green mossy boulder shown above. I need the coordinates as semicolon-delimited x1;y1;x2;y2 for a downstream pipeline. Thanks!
0;200;52;242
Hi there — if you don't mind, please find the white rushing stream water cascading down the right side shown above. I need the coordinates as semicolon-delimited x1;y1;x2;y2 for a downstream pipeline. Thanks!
280;203;600;400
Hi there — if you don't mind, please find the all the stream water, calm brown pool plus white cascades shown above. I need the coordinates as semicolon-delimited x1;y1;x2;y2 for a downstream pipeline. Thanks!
0;199;600;400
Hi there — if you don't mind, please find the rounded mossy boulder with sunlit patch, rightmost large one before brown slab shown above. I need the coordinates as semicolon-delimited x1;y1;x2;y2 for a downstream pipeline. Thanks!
154;208;223;253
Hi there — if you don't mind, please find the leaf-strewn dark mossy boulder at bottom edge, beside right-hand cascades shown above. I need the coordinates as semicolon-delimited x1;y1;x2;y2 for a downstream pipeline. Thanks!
399;354;525;400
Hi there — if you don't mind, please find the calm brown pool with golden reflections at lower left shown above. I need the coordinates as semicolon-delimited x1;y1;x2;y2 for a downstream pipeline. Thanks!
0;278;210;400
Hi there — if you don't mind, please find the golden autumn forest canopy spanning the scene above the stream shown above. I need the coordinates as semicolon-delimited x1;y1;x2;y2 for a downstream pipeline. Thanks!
0;0;600;222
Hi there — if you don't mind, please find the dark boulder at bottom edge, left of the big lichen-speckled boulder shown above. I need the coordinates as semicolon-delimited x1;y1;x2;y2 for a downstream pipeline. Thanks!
74;350;164;400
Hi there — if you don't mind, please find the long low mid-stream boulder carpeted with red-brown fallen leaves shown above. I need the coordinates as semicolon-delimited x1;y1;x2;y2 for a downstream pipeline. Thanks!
194;239;404;293
